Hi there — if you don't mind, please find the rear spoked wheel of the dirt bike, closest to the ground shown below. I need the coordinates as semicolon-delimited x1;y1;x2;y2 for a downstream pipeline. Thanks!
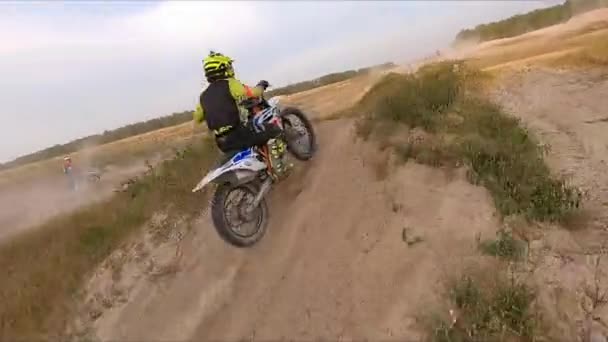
211;184;268;247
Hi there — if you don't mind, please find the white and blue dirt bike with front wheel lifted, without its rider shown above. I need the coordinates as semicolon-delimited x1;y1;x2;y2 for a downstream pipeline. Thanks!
192;97;316;247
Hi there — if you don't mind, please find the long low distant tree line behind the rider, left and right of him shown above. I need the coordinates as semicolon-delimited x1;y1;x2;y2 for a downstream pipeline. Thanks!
0;63;396;170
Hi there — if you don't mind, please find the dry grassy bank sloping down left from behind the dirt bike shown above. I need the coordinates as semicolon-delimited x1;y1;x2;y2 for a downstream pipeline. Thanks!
0;141;215;341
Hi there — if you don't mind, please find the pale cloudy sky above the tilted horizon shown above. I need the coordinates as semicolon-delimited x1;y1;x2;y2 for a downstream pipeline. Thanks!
0;0;556;162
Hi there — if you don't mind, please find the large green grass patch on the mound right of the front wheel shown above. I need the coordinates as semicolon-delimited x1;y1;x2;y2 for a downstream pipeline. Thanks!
357;61;582;221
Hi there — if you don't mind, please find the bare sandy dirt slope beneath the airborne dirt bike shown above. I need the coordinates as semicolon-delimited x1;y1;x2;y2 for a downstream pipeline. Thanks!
84;120;504;341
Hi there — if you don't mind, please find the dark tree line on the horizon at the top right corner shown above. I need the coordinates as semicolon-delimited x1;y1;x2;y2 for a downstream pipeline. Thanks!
454;0;608;46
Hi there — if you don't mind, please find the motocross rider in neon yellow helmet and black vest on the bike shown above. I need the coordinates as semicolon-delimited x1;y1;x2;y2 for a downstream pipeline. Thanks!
193;51;292;179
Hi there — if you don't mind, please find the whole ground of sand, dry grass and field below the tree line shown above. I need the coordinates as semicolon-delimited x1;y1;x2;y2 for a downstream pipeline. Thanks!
0;10;608;341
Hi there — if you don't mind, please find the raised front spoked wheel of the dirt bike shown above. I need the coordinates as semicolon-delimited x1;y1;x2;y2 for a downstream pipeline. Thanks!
281;108;317;160
